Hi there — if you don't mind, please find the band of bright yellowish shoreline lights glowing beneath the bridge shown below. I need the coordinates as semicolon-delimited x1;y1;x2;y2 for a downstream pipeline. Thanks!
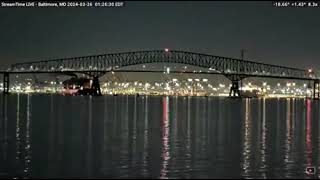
0;78;312;97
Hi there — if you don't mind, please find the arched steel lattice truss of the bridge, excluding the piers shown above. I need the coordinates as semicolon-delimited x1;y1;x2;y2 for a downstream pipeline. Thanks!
10;50;311;78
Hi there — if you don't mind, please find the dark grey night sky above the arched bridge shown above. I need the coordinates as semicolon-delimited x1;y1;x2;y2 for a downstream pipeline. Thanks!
0;1;320;69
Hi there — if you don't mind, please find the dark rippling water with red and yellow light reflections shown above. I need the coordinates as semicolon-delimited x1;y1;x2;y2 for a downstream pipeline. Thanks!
0;95;320;178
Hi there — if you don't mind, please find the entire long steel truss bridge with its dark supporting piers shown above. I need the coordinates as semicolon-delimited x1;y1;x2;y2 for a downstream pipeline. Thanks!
0;49;319;98
